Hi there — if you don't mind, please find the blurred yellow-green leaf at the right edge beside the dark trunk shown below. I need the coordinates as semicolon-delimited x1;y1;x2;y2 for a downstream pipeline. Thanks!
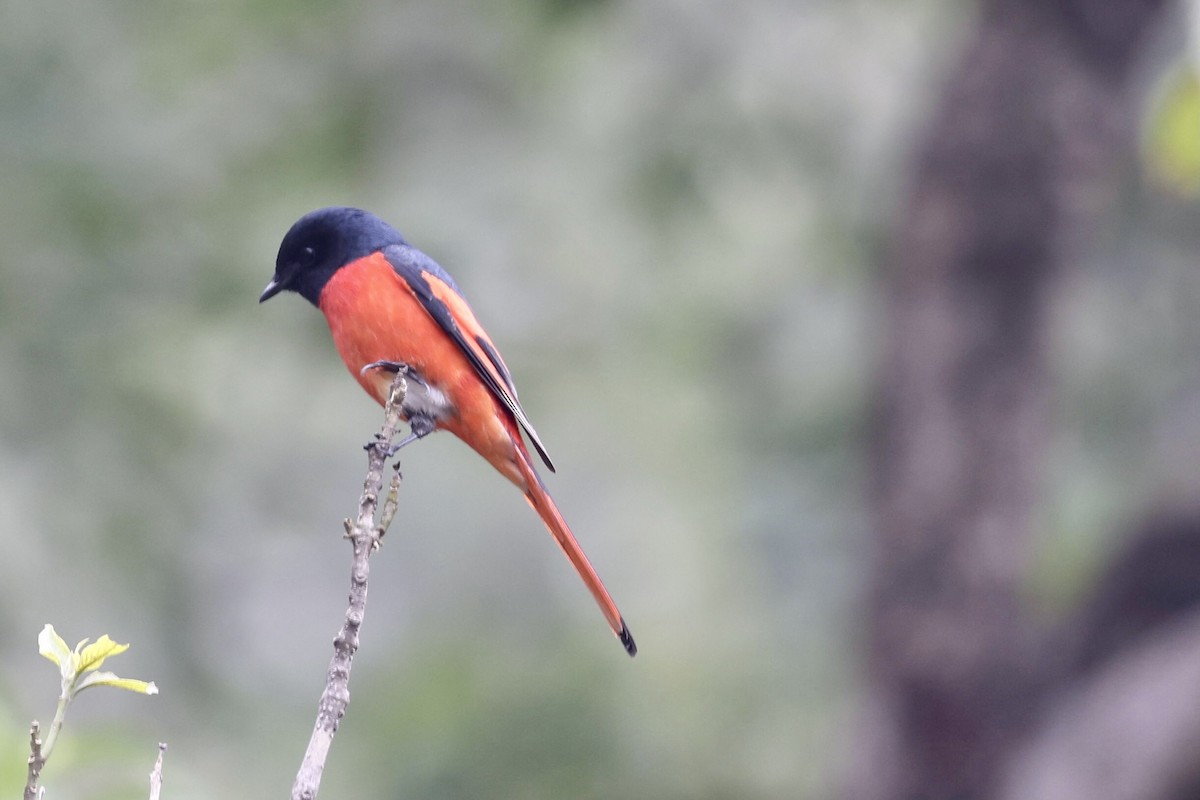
1145;66;1200;197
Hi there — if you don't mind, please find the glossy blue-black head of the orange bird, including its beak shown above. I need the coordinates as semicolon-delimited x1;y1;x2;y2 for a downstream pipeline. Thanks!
258;206;407;306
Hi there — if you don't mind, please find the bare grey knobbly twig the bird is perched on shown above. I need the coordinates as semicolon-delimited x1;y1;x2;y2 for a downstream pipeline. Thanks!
292;372;408;800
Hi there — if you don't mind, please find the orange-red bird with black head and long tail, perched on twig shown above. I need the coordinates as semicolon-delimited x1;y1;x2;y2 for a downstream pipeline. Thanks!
258;206;637;656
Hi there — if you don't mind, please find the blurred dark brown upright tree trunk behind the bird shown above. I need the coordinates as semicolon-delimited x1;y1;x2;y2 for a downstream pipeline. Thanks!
846;0;1169;800
